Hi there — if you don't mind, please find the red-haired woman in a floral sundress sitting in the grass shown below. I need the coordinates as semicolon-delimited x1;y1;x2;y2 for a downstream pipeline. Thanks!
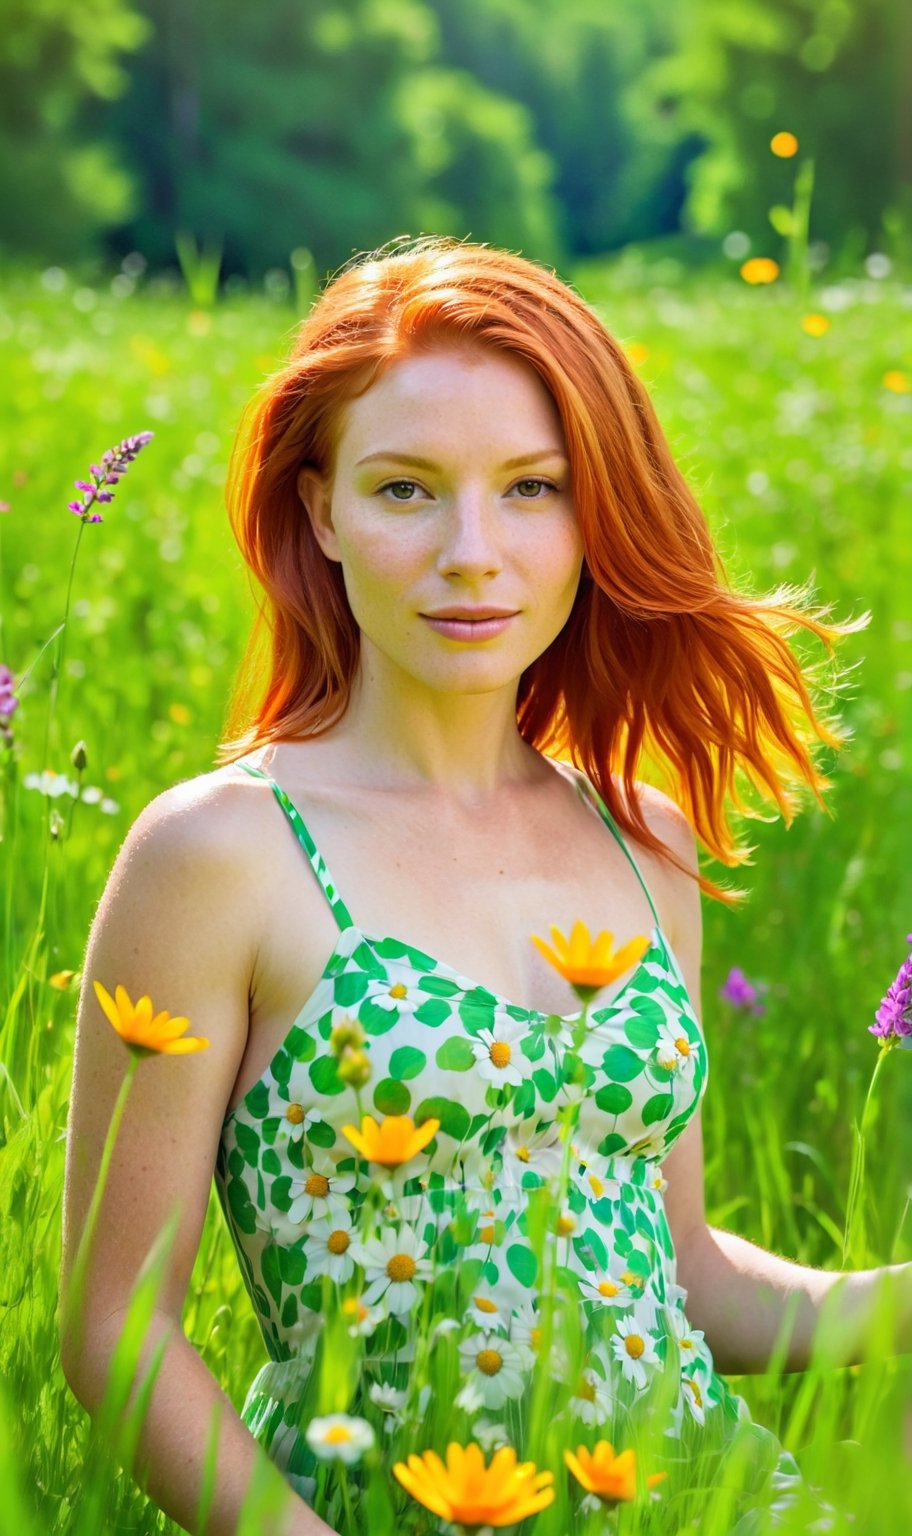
63;240;878;1536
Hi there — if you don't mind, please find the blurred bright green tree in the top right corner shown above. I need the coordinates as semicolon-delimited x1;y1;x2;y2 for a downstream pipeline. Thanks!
640;0;912;258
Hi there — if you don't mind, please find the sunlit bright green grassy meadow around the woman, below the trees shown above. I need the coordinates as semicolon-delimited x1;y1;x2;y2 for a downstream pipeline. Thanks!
0;250;912;1536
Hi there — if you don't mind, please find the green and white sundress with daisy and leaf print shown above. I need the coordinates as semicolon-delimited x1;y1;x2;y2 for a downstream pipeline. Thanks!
215;762;828;1531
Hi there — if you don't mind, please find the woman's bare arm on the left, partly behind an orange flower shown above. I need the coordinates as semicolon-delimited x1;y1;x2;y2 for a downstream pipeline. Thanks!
60;780;332;1536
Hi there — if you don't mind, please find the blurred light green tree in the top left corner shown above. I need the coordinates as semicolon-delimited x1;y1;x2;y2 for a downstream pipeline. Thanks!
0;0;149;261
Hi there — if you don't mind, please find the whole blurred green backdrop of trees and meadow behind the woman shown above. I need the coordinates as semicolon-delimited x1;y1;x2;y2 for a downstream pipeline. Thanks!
0;0;912;1536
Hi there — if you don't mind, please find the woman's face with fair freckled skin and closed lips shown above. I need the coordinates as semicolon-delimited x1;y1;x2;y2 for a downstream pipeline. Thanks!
298;344;583;693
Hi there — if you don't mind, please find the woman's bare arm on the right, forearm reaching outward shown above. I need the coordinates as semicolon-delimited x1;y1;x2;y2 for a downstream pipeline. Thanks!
642;790;912;1373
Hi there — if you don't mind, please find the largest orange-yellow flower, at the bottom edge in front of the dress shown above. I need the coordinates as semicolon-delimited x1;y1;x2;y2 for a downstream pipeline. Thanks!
393;1441;554;1527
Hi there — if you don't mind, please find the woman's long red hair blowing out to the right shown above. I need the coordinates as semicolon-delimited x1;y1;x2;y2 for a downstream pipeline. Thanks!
218;237;857;894
